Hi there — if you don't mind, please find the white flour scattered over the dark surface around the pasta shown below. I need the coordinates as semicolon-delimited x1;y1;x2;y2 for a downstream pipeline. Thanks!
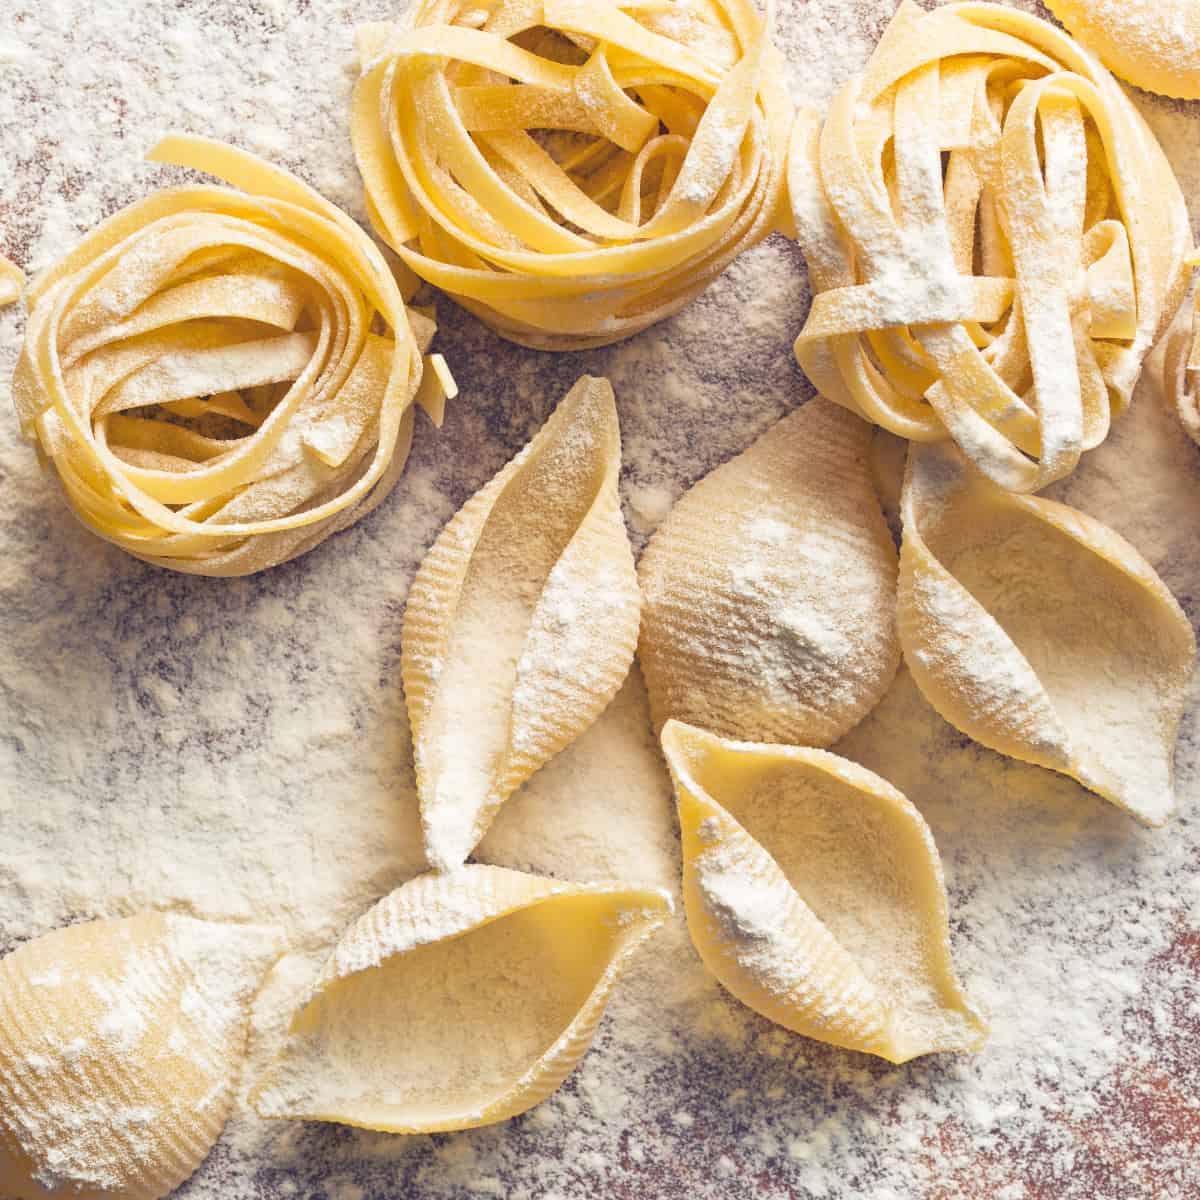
0;0;1200;1200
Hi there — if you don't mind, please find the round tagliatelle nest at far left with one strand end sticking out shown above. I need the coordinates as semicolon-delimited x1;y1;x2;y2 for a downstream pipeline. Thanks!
13;137;454;575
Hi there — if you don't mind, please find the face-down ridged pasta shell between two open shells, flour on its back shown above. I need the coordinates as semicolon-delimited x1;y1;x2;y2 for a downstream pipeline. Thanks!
638;400;900;746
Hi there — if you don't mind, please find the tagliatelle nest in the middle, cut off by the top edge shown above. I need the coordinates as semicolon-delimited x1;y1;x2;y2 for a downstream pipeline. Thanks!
352;0;791;350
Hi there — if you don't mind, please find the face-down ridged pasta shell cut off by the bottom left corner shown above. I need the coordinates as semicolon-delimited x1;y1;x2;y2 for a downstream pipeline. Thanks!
0;913;275;1200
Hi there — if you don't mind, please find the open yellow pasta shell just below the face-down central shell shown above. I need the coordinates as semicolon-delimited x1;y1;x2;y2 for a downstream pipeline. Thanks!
662;721;986;1062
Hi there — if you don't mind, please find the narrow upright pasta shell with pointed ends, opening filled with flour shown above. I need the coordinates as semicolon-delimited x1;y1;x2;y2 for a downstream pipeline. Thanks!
401;377;641;868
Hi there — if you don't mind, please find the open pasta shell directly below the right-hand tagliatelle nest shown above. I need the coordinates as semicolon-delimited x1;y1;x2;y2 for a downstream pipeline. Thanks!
899;445;1195;826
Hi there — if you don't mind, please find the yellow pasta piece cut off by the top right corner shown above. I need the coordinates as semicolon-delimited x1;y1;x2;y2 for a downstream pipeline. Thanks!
1046;0;1200;100
